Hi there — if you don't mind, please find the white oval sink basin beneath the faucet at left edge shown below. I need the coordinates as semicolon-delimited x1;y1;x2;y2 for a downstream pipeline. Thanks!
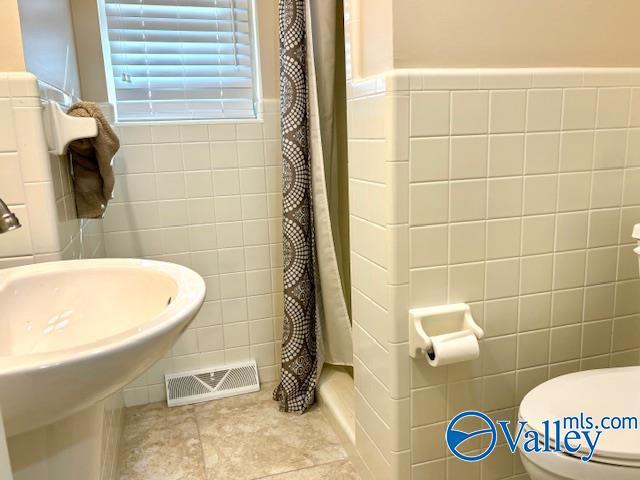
0;259;205;436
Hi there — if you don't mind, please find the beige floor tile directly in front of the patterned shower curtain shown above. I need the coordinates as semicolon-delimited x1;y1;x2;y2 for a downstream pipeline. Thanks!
195;387;347;480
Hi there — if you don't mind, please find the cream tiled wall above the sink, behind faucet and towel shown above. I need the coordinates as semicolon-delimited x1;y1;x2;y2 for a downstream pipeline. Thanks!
0;73;102;268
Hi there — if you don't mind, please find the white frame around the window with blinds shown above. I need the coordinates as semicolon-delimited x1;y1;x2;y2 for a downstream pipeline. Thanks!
95;0;264;125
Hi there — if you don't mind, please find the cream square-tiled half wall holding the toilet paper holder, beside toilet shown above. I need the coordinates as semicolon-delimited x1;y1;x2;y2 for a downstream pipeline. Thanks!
348;69;640;480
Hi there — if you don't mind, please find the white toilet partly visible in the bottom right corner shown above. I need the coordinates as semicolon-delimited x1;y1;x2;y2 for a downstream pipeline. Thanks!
518;224;640;480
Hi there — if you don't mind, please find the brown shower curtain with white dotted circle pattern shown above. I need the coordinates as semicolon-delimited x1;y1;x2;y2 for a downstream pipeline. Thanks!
273;0;318;412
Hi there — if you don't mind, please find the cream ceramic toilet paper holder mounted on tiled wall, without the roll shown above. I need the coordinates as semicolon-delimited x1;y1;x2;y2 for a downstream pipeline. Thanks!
409;303;484;358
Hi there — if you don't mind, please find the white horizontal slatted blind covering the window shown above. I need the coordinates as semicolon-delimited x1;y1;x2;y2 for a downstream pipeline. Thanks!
103;0;256;121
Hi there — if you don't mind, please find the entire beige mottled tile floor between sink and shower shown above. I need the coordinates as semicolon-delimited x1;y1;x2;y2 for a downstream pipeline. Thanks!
120;385;360;480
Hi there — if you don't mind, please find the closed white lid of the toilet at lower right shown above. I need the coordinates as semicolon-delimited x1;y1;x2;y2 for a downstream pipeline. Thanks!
519;367;640;463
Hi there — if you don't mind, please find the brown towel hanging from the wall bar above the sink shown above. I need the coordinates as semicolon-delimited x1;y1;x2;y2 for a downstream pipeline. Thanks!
67;102;120;218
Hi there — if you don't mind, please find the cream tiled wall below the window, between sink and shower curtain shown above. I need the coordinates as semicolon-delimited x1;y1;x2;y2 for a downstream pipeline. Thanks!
104;101;283;405
